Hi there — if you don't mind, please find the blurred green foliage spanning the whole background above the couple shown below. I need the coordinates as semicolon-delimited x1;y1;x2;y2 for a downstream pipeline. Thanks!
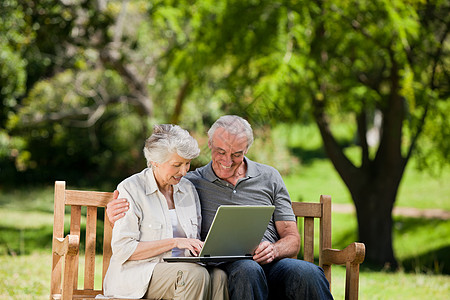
0;0;450;200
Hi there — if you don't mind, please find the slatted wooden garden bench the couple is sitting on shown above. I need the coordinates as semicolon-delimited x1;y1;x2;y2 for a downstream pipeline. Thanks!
50;181;365;299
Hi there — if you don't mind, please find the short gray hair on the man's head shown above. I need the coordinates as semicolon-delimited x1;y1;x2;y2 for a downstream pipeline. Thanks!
208;115;253;150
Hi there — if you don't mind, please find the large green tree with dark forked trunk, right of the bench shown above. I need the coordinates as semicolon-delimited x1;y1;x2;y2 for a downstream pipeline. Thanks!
198;1;450;267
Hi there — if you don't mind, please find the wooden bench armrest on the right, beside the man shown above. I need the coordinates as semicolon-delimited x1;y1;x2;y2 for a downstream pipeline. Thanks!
322;242;366;265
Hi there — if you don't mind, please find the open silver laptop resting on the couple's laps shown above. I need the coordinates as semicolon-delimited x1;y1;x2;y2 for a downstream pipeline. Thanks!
164;205;275;263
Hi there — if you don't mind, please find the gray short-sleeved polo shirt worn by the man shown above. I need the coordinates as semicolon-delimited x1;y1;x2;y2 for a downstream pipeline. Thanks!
185;158;295;243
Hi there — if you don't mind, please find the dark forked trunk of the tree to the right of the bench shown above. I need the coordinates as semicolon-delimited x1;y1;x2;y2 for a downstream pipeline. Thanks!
314;92;407;268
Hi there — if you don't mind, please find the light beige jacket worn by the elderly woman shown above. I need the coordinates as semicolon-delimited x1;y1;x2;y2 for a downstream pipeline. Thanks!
103;168;201;298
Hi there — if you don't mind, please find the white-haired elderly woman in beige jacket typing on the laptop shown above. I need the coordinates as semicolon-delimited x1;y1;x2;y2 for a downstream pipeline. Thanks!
104;125;228;299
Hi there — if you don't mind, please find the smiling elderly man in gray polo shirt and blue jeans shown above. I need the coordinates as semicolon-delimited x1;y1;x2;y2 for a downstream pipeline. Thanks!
107;116;332;300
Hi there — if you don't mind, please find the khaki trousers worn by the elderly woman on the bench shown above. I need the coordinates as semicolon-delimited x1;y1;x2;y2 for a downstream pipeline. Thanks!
145;262;229;300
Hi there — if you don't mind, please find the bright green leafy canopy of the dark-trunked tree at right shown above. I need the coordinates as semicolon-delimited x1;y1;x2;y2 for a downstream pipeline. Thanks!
198;1;449;171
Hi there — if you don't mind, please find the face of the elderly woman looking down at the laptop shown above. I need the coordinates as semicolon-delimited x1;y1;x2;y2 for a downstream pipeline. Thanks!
153;153;191;187
